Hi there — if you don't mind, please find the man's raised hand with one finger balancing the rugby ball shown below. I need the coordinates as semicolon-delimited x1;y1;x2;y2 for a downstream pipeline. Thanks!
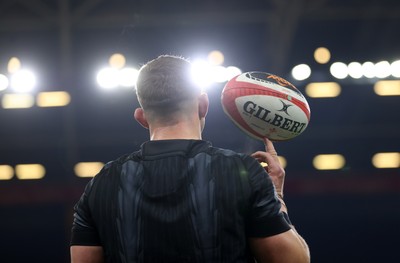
251;138;285;198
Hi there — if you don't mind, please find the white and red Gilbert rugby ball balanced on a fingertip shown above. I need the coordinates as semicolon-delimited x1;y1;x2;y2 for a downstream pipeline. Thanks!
221;72;310;141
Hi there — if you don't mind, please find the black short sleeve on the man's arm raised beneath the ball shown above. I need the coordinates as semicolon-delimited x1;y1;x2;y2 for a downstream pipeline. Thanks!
244;156;290;237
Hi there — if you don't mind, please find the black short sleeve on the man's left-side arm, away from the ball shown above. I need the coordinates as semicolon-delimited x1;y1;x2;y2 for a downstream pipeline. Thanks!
70;169;104;246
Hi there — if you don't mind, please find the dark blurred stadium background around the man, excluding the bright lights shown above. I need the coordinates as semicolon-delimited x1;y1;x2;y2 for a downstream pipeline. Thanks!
0;0;400;263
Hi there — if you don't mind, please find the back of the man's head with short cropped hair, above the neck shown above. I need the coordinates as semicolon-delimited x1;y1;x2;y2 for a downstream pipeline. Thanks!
136;55;201;123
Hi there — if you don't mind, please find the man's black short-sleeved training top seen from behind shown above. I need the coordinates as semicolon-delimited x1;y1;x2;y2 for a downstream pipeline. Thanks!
71;140;290;263
